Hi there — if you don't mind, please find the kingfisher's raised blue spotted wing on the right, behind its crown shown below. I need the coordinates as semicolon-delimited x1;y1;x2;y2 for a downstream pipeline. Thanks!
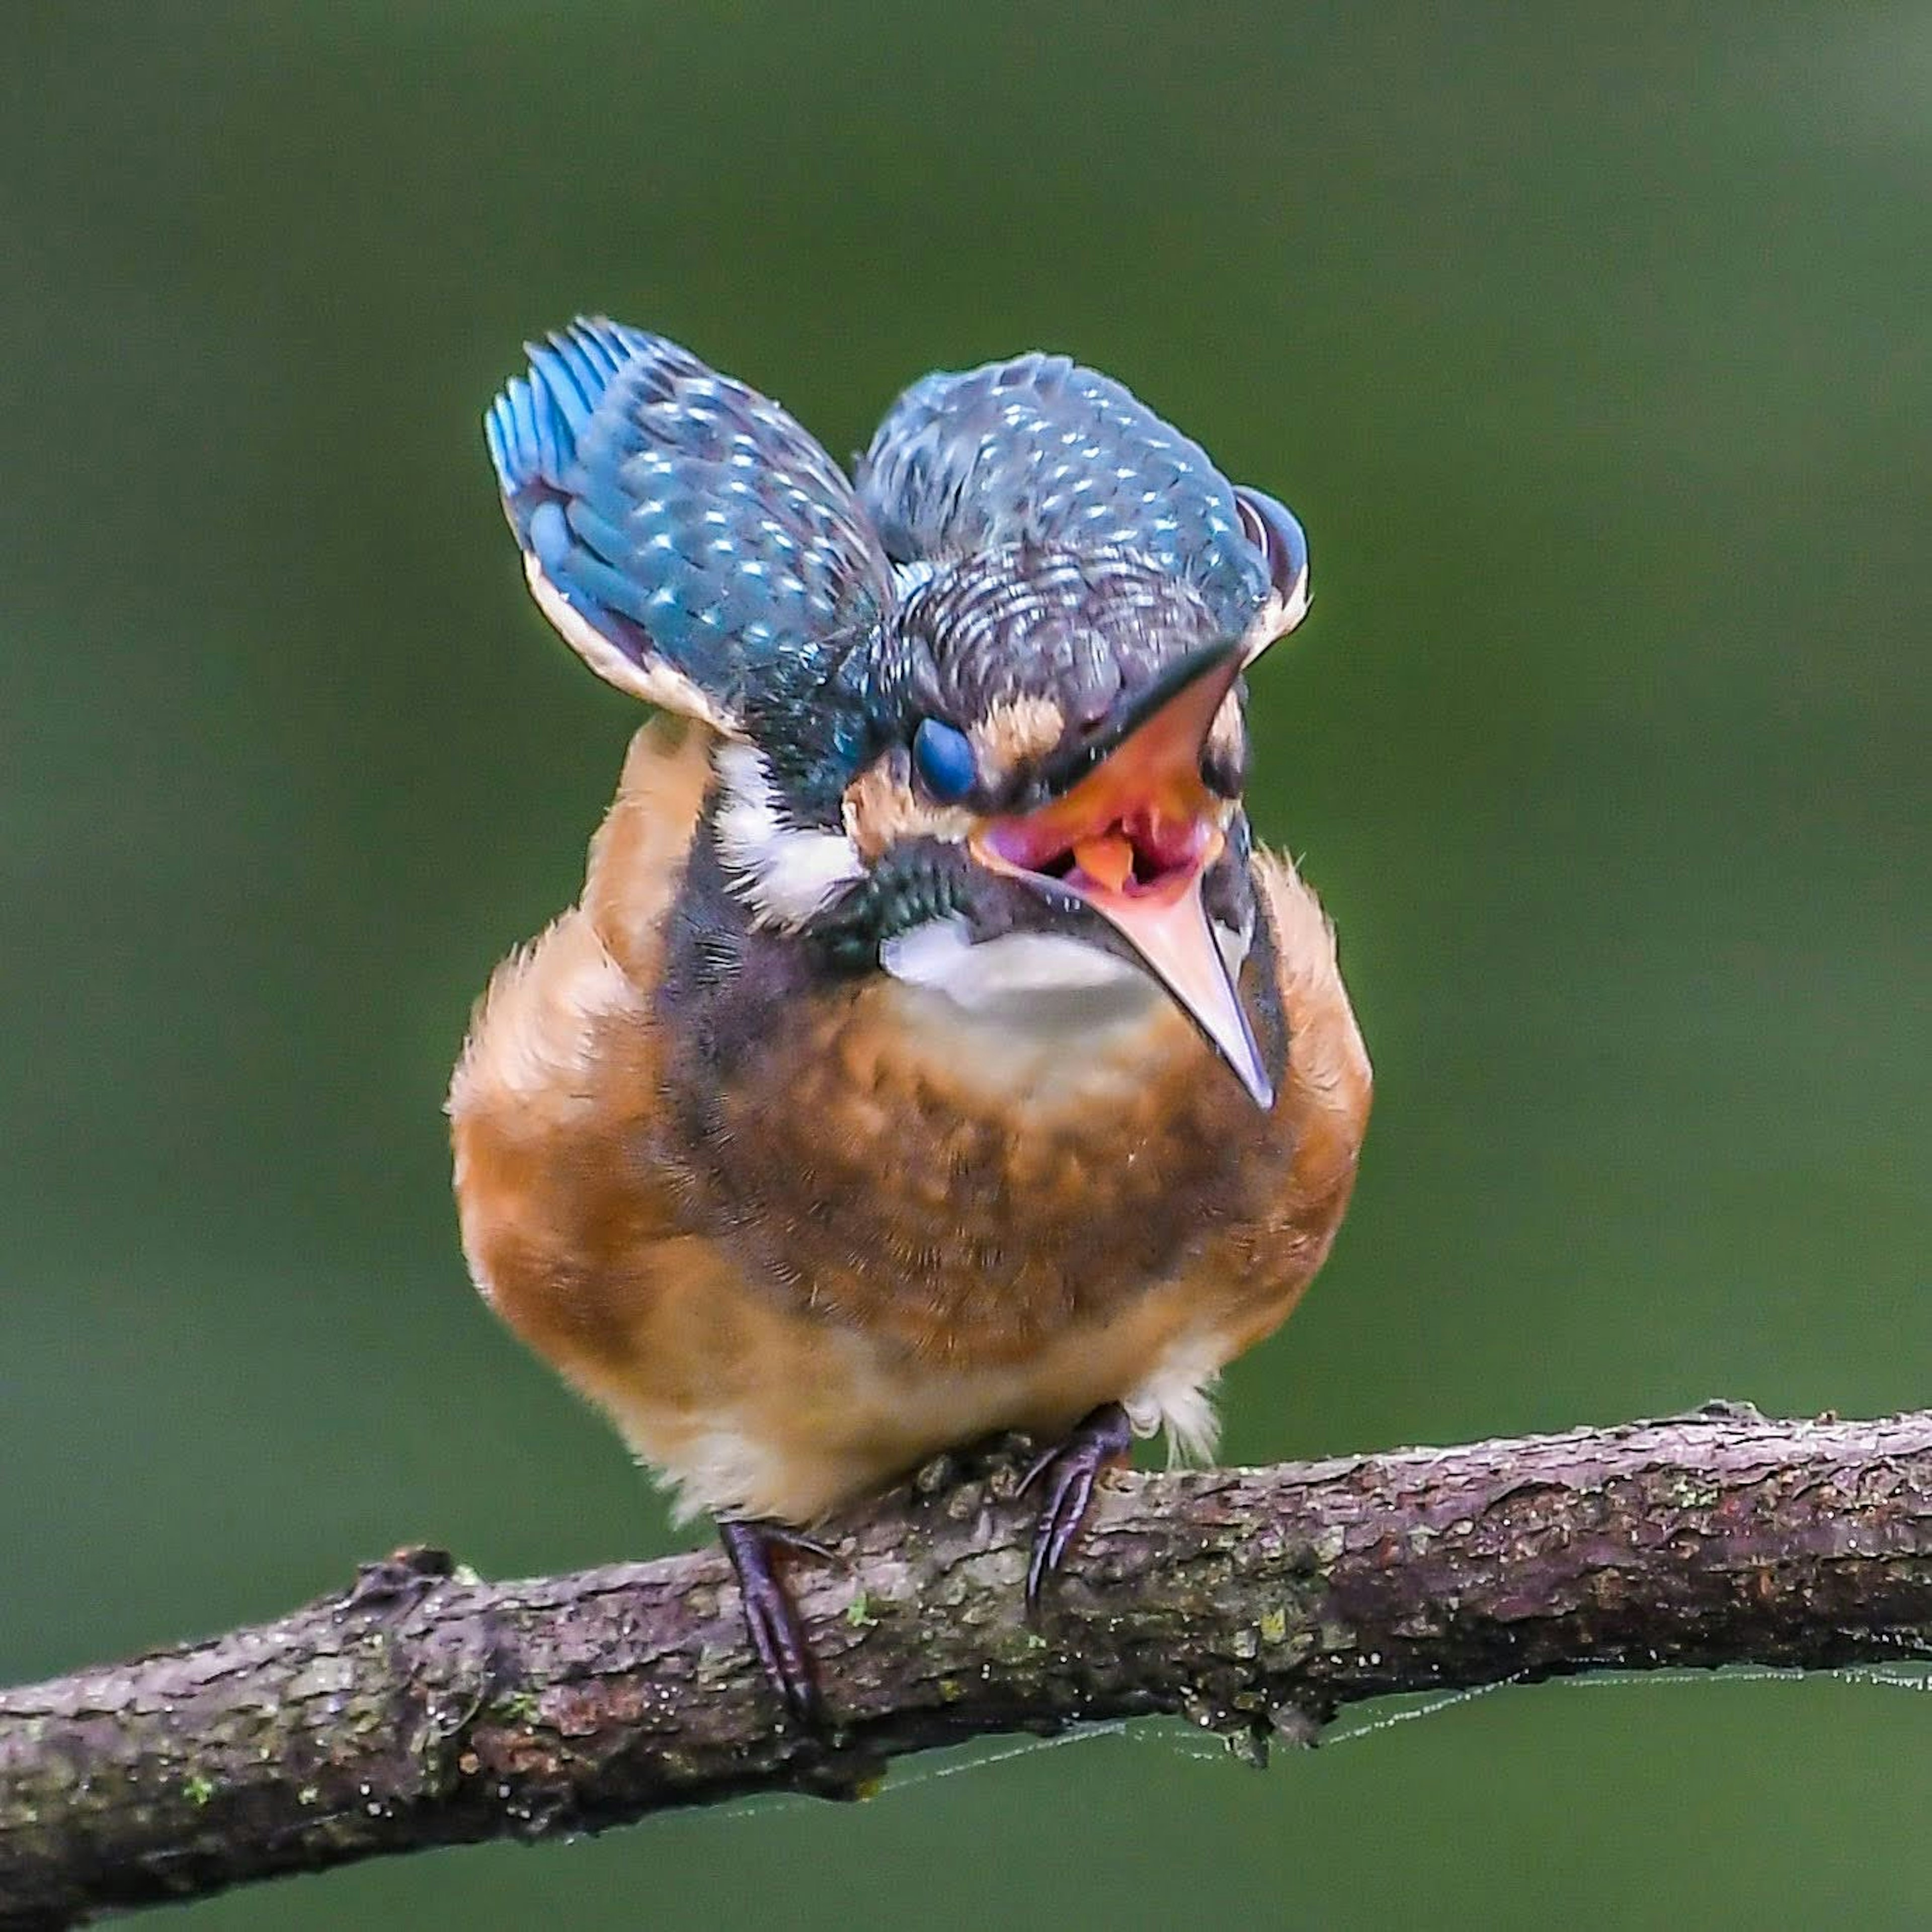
856;354;1308;634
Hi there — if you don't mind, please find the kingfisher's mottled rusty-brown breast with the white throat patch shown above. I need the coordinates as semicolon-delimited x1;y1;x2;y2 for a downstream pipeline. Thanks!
659;854;1285;1366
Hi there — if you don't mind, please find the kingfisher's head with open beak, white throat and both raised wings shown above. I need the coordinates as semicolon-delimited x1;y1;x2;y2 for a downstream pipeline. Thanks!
487;323;1308;1107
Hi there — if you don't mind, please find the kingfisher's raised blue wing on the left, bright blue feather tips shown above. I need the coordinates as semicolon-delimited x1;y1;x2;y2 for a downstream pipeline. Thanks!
483;319;891;734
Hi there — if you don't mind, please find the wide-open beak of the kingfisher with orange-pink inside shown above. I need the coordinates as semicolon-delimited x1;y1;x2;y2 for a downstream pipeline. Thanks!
972;641;1275;1107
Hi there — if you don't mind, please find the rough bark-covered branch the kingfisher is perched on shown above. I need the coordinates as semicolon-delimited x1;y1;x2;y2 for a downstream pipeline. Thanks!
0;1405;1932;1928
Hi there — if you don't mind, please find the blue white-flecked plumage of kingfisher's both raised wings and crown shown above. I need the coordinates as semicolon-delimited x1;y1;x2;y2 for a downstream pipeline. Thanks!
485;317;1308;808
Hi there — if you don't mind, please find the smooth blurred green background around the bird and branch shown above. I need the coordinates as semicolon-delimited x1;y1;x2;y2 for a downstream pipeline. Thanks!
0;0;1932;1932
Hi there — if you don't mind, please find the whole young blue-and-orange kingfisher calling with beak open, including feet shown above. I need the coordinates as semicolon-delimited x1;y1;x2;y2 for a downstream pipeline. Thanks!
448;319;1370;1723
